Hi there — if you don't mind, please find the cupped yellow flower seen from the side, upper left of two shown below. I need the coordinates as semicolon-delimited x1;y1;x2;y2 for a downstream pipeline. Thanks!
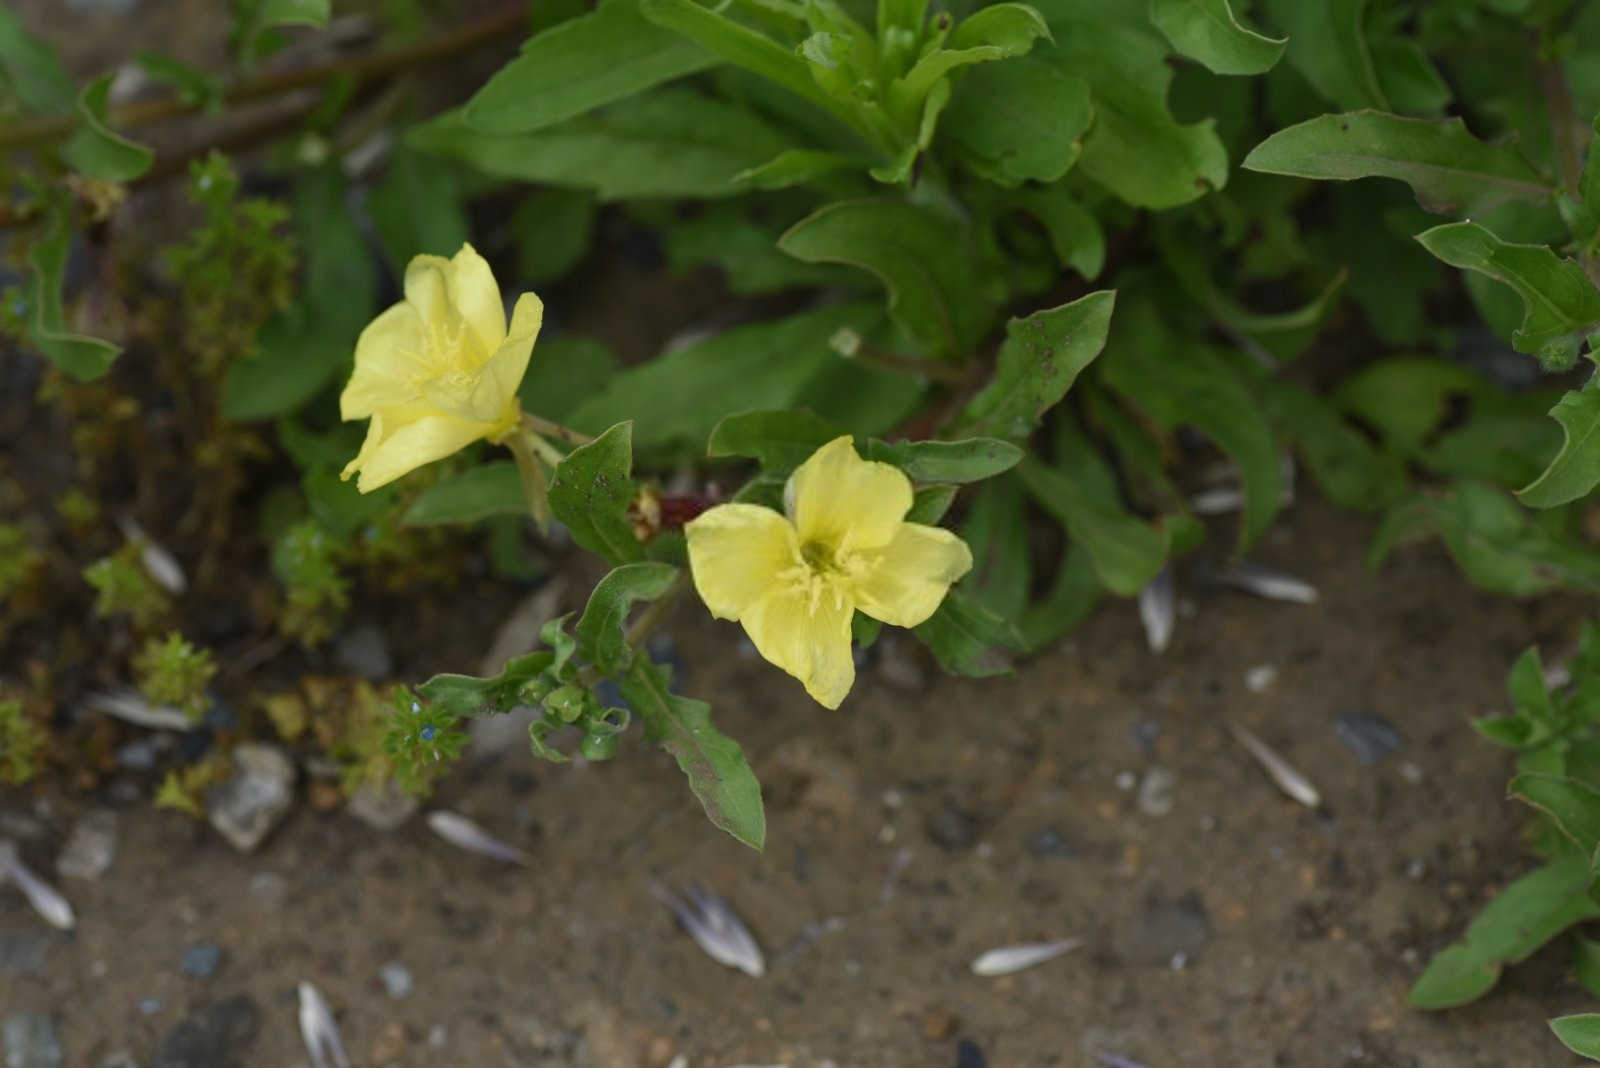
339;245;544;492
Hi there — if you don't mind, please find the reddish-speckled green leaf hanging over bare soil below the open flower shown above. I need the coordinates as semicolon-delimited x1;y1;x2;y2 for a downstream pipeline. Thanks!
618;657;766;849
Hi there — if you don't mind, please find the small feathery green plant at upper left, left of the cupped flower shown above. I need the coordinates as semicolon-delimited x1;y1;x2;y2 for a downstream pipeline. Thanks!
166;152;294;374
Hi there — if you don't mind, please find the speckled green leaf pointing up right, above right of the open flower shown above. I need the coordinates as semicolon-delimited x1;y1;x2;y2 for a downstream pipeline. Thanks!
960;289;1117;438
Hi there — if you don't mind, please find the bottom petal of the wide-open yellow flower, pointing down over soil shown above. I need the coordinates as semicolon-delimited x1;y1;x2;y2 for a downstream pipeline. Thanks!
739;587;856;708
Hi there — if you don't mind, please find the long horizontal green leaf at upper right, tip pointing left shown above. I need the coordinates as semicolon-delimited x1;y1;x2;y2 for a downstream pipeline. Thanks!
1242;110;1552;217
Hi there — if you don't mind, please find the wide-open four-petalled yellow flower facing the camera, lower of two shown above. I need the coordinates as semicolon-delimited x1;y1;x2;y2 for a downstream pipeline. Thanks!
683;436;973;708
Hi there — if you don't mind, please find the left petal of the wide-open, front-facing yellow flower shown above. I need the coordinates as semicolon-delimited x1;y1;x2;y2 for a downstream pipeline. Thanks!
683;504;800;619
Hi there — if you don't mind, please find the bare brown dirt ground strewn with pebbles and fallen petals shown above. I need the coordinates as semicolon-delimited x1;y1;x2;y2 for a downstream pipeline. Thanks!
0;500;1586;1068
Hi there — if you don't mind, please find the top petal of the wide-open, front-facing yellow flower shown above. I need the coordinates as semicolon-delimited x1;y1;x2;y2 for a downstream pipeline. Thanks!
784;435;912;553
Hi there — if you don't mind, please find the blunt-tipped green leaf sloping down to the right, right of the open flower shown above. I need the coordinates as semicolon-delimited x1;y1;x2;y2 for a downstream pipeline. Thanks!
1016;454;1170;596
